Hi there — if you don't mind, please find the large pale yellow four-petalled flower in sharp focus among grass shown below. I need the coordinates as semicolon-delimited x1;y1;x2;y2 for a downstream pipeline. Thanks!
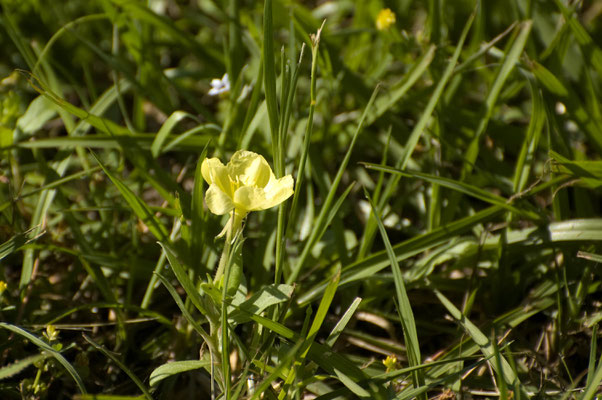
201;150;294;238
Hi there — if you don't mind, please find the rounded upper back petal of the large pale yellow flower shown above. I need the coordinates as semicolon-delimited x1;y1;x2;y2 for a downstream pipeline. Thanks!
228;150;272;187
